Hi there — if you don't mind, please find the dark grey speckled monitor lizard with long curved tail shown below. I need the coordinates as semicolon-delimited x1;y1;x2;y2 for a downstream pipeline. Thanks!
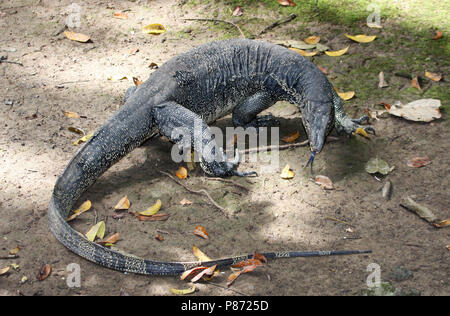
48;40;371;275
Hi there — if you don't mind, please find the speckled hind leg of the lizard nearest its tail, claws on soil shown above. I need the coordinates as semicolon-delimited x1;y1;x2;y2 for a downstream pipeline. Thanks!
152;102;256;177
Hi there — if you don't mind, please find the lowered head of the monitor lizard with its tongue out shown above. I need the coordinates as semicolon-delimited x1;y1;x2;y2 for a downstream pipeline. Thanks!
302;101;334;175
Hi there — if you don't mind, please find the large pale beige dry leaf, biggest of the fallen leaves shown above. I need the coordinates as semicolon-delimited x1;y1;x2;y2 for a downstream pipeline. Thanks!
388;99;442;122
